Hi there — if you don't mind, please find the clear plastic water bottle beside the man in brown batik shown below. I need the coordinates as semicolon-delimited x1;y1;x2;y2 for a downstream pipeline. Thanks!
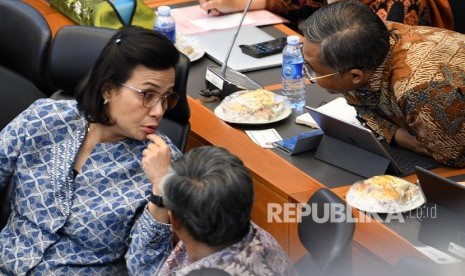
282;35;305;109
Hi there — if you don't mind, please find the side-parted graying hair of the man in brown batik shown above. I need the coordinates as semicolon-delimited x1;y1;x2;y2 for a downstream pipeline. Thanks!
304;0;389;72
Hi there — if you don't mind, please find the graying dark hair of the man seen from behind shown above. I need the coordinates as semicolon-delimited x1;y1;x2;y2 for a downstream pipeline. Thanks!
163;146;254;246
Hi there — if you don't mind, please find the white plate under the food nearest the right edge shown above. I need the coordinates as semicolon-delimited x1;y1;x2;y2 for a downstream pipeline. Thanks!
346;177;425;214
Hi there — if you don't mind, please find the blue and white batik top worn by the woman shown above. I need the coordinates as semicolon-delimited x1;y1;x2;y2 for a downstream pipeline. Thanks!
0;99;181;275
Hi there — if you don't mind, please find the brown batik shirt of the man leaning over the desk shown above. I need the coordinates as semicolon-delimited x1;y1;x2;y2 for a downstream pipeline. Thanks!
345;22;465;167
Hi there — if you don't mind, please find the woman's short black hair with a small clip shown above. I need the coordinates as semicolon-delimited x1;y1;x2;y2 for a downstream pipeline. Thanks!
75;26;179;125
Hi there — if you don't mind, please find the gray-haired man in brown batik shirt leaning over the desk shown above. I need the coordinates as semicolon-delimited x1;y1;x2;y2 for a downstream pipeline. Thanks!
302;0;465;167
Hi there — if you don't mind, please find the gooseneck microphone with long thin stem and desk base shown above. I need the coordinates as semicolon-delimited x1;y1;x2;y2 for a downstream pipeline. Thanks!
200;0;263;100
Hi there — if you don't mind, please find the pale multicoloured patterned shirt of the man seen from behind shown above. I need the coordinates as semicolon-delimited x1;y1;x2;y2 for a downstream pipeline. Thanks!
157;224;296;276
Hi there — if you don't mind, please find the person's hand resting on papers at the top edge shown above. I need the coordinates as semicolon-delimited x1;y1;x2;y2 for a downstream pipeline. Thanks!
199;0;266;15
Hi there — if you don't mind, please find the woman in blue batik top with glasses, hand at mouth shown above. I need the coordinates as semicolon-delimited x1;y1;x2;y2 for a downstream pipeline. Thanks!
0;27;181;275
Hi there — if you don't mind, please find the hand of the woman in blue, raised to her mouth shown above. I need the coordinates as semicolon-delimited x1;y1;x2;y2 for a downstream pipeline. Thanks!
142;134;171;195
